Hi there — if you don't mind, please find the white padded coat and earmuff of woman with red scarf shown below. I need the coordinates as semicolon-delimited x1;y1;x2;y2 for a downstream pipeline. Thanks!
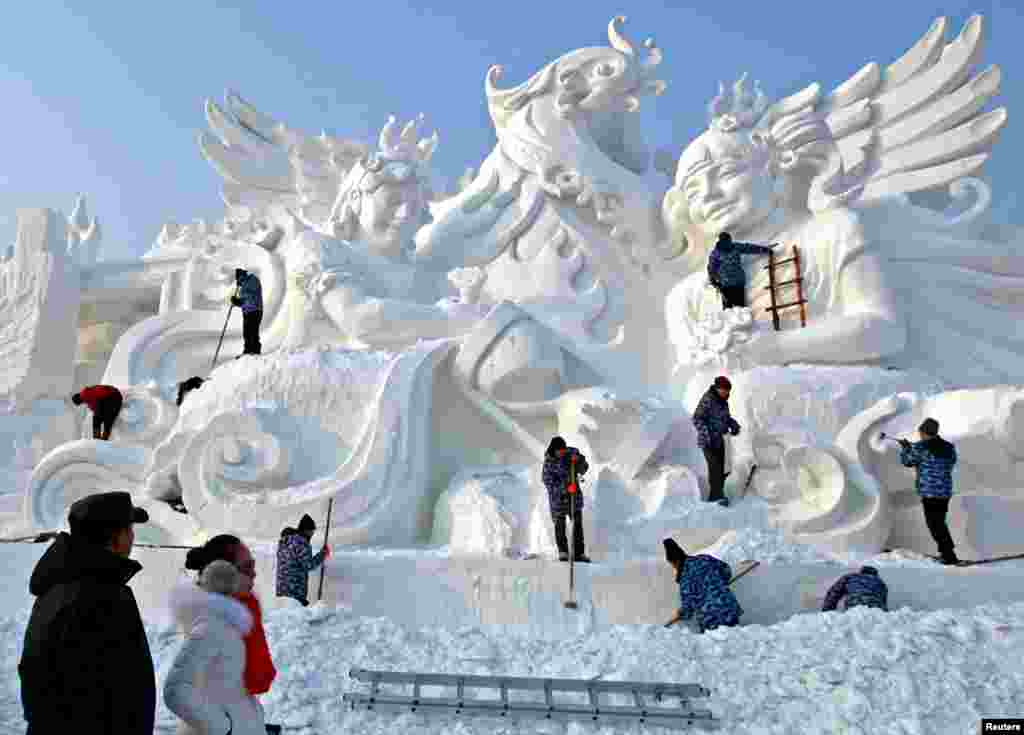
164;561;266;735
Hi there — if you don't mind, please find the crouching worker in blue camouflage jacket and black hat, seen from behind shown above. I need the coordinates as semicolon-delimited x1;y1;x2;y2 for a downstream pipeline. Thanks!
663;538;743;633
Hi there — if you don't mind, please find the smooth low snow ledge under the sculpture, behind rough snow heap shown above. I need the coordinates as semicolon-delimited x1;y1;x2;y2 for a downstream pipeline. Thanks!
18;544;1024;638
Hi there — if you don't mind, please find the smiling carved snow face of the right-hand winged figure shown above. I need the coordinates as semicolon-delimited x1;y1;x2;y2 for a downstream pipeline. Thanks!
676;130;778;236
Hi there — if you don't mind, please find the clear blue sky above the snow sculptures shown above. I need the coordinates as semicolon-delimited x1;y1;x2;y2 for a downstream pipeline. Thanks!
0;0;1024;258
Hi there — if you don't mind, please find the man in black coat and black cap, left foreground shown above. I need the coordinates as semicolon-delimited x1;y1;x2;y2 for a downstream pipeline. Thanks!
17;492;157;735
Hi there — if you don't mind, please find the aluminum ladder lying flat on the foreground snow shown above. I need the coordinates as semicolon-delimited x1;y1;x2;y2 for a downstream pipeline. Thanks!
343;668;720;730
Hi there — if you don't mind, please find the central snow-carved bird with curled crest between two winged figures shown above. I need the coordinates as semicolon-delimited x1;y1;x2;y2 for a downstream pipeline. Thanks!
416;17;685;389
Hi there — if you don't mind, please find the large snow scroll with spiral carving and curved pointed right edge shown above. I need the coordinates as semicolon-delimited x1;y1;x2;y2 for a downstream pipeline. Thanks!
147;342;452;544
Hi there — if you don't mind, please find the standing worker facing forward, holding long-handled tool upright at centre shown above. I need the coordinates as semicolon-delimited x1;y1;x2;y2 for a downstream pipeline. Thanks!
541;436;590;564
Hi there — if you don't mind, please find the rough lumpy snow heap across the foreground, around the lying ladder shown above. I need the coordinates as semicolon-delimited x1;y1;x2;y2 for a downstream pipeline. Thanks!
8;604;1024;735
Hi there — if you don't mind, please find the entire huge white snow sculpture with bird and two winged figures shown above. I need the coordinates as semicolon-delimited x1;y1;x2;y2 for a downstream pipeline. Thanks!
14;17;1024;565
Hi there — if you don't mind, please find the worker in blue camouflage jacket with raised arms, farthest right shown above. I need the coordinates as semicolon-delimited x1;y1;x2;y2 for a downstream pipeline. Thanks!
899;419;959;565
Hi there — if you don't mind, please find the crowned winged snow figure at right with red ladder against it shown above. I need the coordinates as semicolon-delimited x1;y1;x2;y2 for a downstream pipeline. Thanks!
664;16;1024;385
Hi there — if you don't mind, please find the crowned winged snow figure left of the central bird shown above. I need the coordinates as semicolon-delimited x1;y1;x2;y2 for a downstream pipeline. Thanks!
200;107;468;349
